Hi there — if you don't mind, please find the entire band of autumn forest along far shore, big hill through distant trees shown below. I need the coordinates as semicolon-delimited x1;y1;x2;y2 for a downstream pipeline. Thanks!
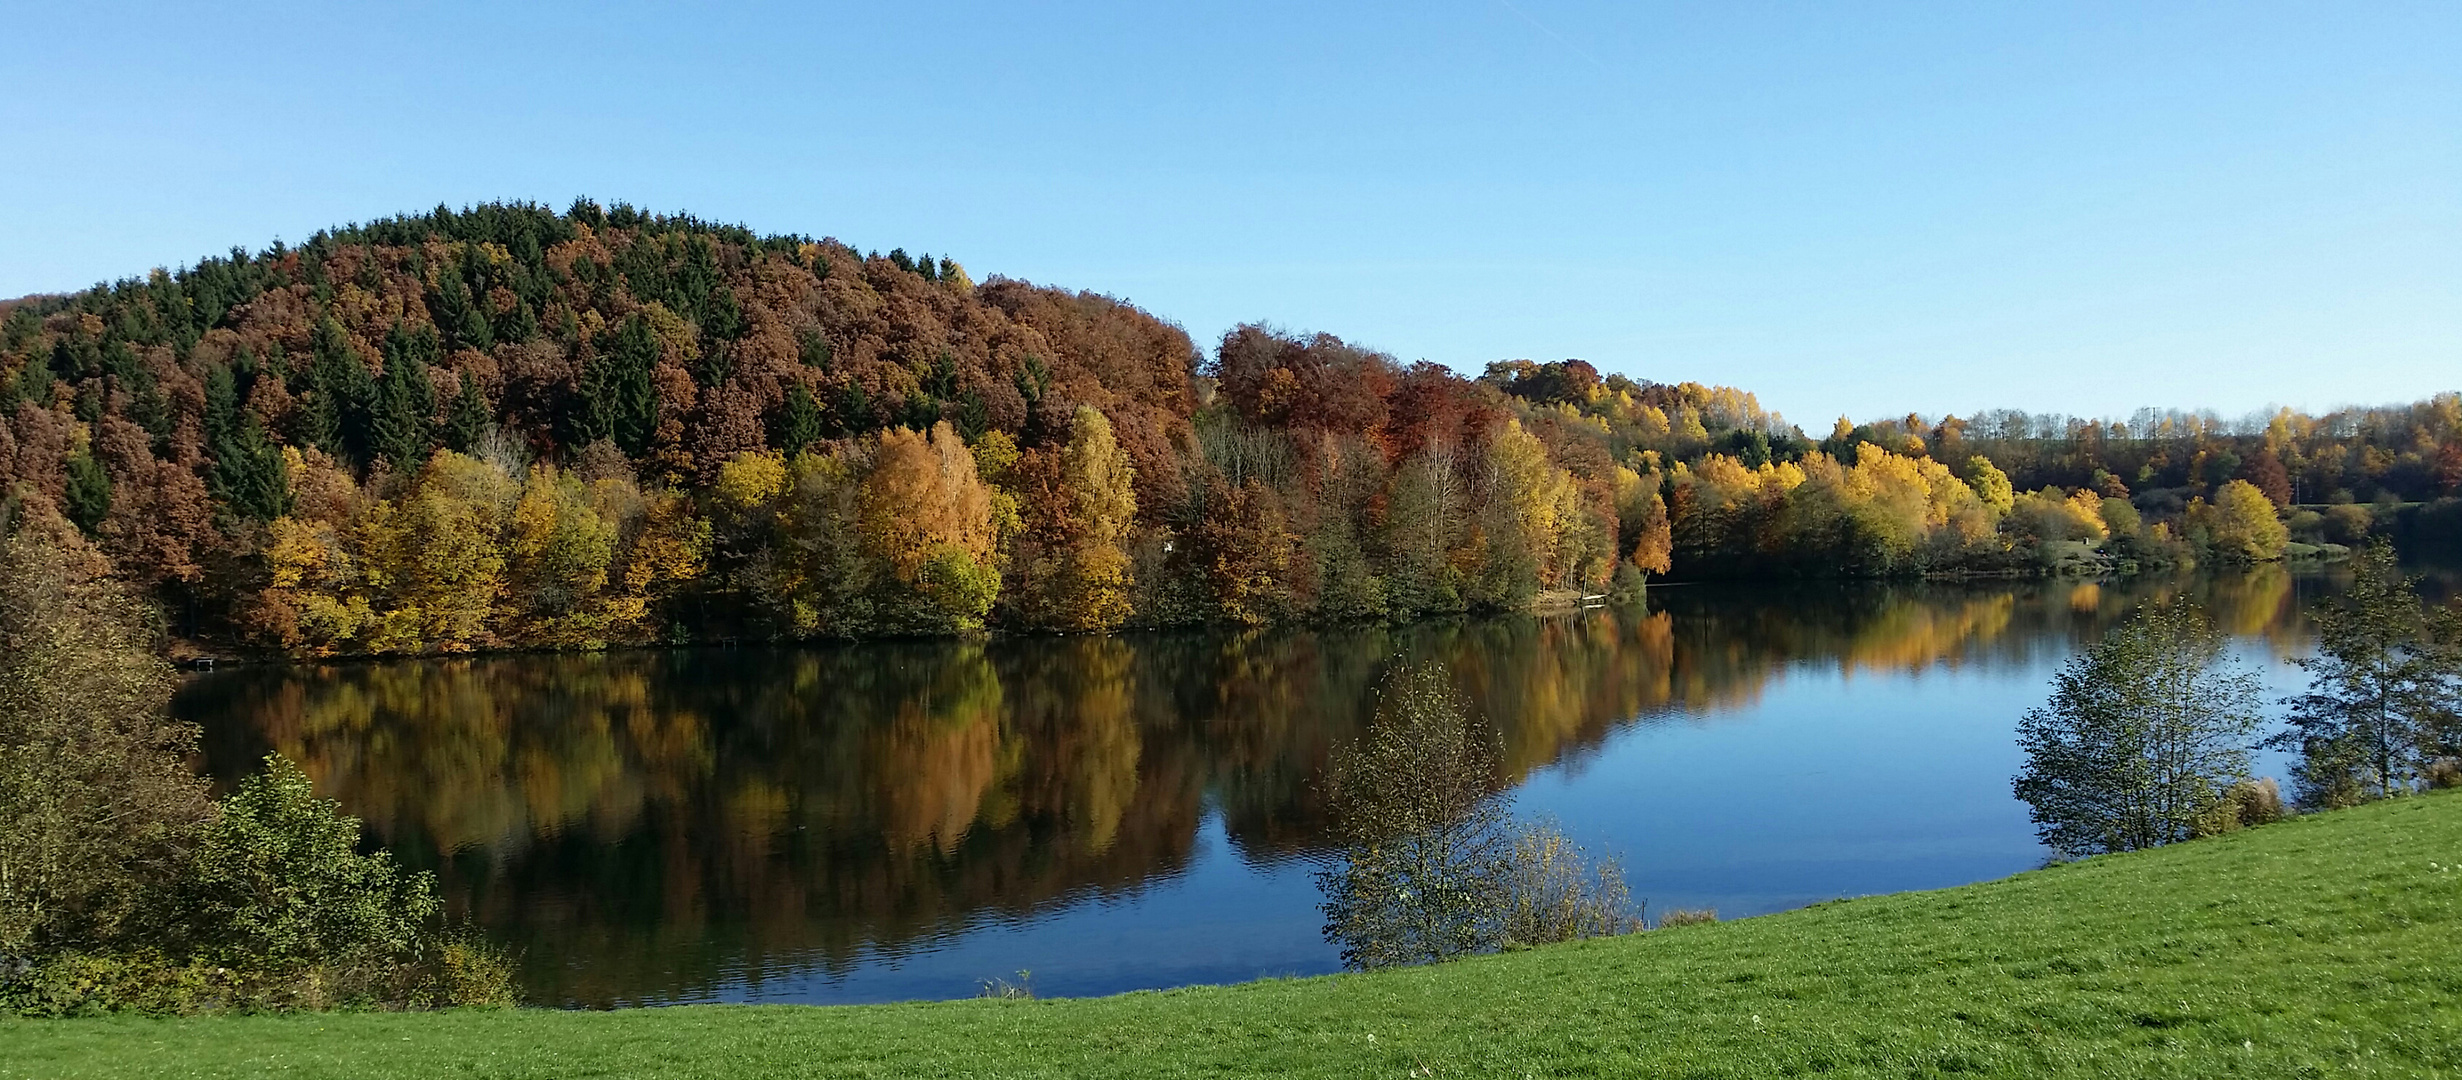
0;202;2462;654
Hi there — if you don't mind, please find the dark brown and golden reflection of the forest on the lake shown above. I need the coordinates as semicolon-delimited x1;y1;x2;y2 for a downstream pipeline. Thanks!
182;571;2309;1004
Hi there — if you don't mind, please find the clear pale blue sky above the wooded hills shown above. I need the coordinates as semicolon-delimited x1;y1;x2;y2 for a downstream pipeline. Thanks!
0;0;2462;431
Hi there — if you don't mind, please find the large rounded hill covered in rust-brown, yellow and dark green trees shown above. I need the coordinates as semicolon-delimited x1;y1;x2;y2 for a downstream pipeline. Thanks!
0;202;1674;652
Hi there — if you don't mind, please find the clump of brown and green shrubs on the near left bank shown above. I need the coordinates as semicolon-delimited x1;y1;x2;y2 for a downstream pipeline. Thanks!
0;522;512;1016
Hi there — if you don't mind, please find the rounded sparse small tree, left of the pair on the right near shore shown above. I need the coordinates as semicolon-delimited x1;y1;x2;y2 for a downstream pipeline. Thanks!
2014;605;2263;856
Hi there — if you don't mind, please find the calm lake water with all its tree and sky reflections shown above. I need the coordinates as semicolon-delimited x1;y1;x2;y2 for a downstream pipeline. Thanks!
177;568;2334;1006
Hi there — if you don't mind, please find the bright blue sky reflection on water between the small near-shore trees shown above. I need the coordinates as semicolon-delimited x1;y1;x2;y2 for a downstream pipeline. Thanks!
1519;664;2051;915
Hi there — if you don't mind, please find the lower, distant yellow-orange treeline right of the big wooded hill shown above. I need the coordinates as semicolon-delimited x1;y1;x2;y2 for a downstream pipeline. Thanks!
1485;362;2462;576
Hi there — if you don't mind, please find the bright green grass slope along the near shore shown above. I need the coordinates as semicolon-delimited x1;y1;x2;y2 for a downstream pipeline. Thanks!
0;795;2462;1078
